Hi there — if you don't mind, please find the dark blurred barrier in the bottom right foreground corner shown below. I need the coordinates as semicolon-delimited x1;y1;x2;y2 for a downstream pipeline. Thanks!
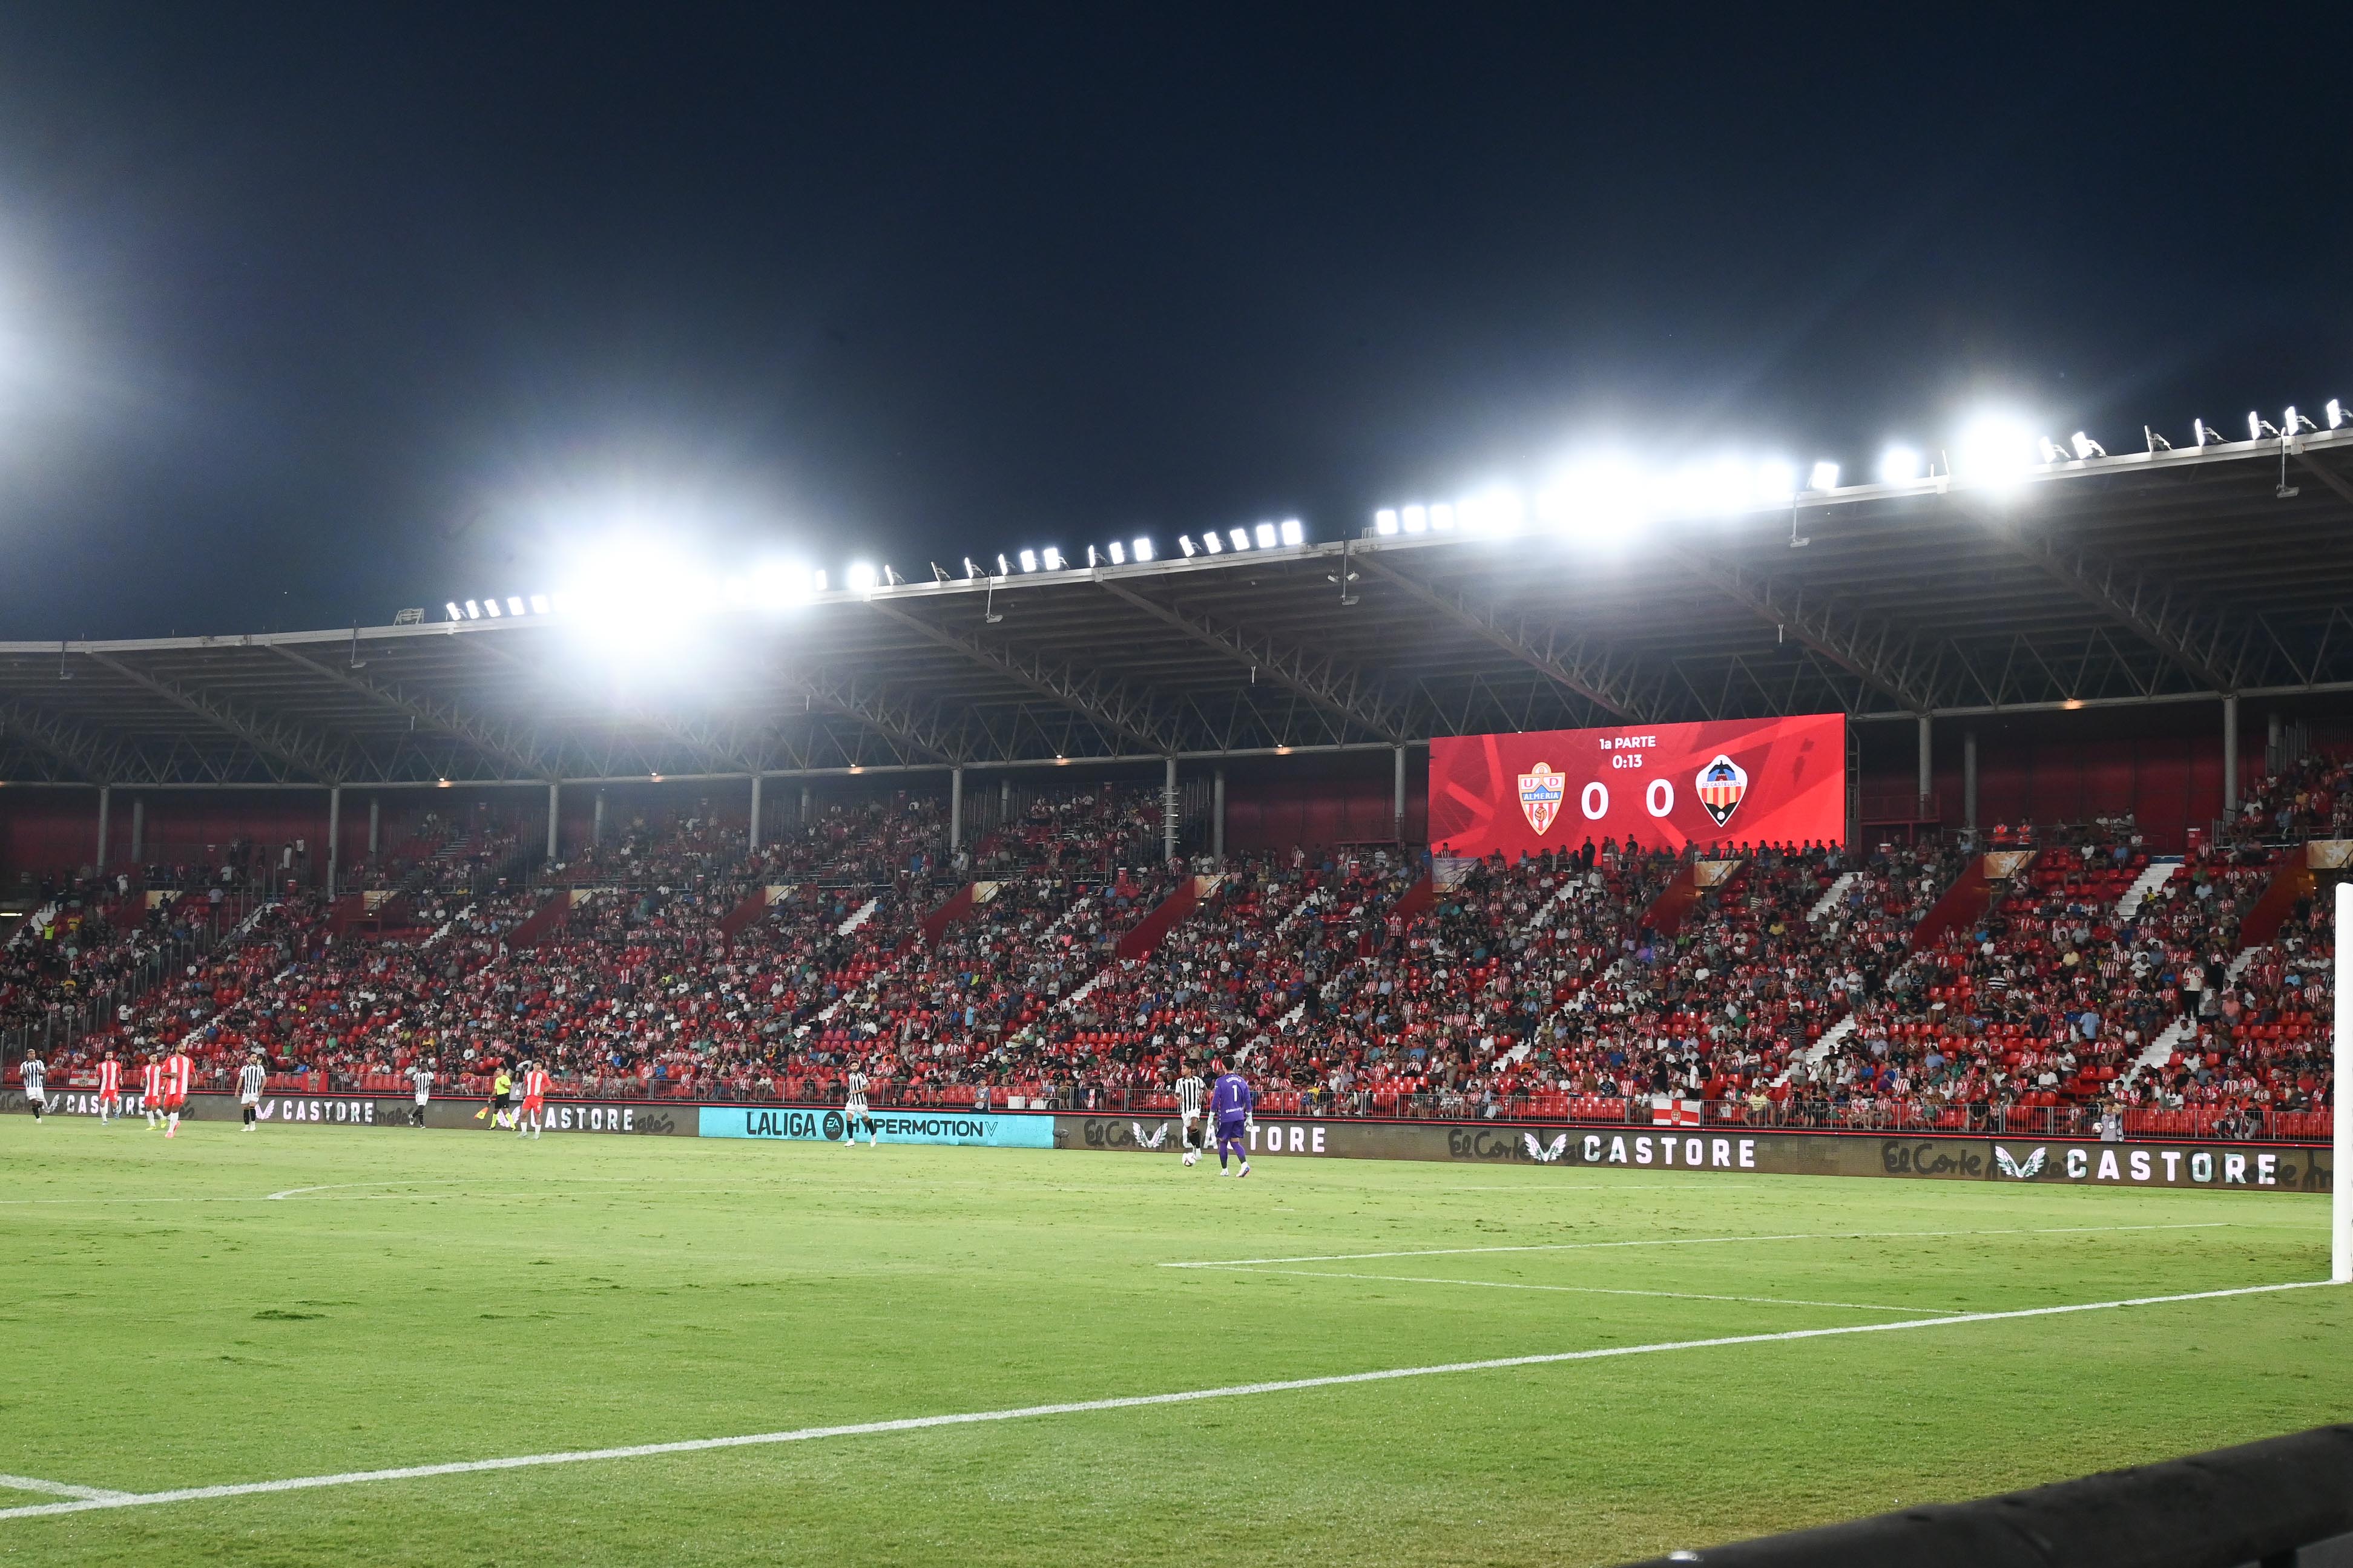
1640;1427;2353;1568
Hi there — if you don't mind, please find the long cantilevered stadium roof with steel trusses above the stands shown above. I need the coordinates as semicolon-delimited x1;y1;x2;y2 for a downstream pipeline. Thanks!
0;428;2353;787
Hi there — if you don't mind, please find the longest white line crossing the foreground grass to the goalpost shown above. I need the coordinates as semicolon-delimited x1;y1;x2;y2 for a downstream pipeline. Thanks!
0;1279;2329;1518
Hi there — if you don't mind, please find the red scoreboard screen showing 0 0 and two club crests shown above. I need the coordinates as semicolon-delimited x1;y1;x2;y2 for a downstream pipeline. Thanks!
1430;712;1847;861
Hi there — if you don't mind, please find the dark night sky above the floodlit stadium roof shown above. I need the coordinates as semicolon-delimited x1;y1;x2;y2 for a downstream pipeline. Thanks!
0;2;2353;637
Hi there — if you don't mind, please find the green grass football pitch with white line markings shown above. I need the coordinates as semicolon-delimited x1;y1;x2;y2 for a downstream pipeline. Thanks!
0;1117;2353;1566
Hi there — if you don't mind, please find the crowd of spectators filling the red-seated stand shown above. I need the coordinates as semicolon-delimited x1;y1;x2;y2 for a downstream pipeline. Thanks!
0;785;2332;1130
